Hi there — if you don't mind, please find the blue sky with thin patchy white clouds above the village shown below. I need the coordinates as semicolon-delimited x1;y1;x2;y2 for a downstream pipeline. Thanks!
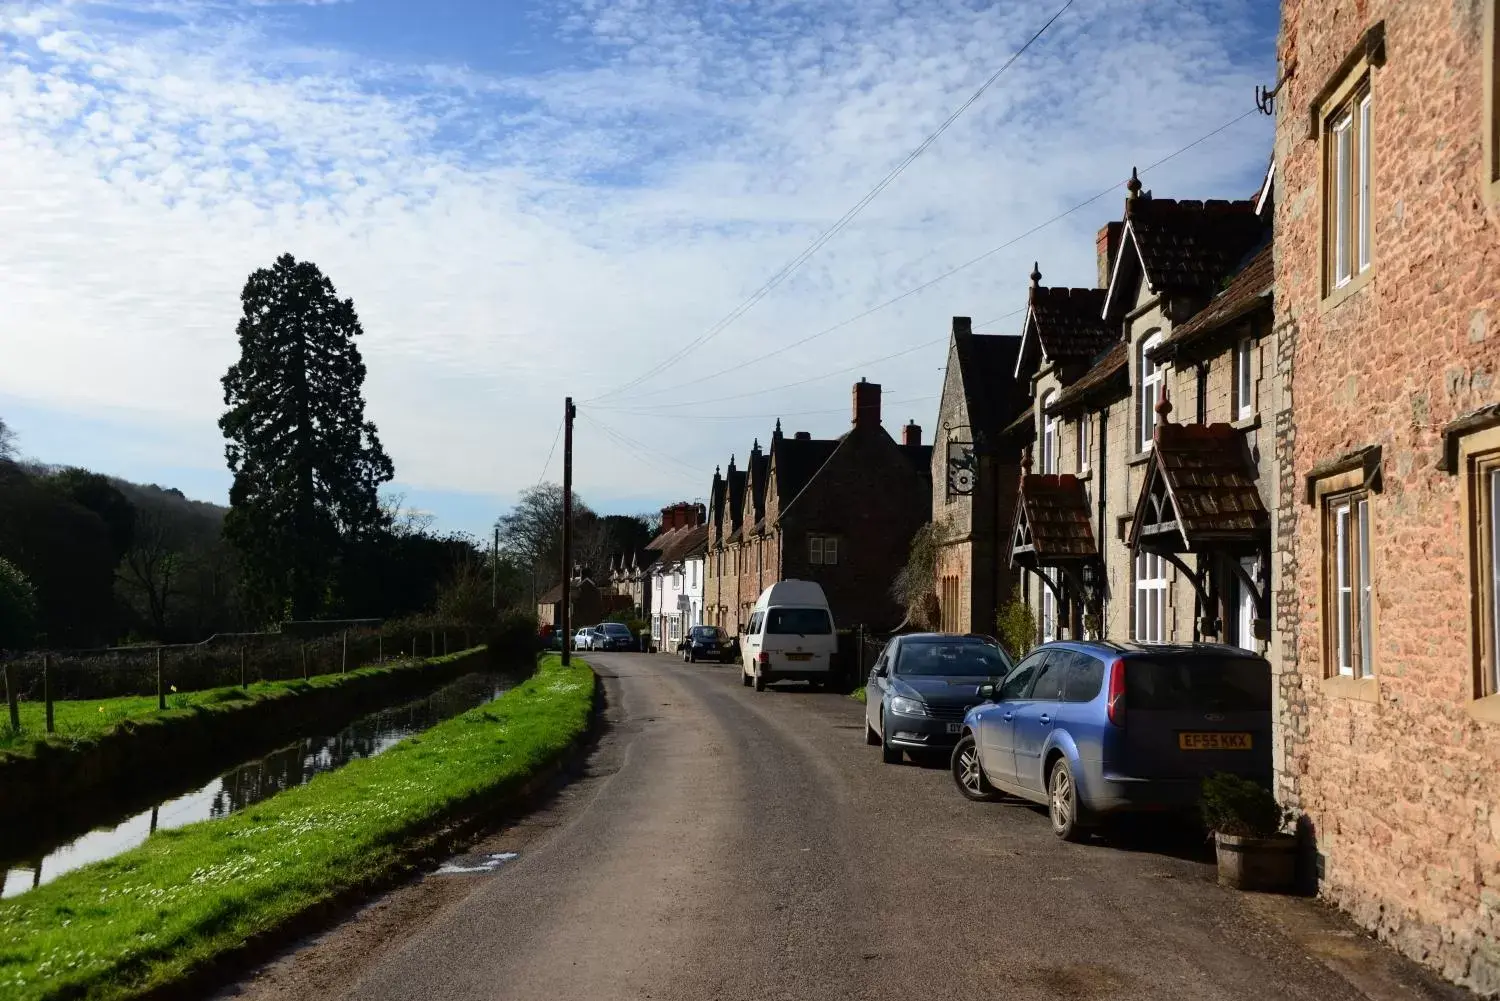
0;0;1277;536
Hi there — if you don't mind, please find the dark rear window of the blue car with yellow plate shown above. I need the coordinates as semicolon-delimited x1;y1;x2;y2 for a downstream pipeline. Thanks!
1125;657;1271;713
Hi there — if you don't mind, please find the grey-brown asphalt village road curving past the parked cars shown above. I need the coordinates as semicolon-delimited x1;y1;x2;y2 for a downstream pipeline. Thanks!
221;654;1461;1001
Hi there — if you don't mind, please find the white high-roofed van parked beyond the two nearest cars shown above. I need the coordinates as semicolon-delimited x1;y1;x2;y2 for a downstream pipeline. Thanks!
740;581;839;692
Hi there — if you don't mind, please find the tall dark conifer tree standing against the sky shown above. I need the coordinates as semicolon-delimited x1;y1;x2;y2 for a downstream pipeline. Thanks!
219;254;395;618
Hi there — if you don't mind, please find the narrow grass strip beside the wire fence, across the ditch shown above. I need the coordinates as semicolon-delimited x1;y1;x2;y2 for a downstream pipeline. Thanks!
0;647;477;767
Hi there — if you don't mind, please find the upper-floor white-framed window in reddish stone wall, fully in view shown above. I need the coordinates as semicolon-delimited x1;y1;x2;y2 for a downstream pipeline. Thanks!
1323;75;1374;294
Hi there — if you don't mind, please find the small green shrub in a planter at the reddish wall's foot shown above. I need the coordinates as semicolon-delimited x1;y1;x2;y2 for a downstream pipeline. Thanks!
1200;771;1298;893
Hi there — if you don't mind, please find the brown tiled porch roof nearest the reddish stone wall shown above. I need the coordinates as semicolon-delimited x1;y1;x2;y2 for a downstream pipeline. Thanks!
1130;420;1271;552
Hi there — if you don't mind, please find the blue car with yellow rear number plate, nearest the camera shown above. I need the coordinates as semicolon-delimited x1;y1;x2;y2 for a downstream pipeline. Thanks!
951;642;1271;840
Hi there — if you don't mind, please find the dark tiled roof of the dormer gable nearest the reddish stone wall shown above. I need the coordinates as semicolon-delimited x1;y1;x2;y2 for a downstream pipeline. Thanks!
1127;198;1266;291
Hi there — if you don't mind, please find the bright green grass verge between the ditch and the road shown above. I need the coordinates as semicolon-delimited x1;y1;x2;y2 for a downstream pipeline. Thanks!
0;656;594;1001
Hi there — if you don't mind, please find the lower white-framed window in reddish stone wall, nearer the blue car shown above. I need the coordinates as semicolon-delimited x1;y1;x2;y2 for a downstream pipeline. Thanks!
1323;491;1374;678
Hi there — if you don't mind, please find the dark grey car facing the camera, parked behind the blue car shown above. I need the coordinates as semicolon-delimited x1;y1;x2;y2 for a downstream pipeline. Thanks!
864;633;1011;764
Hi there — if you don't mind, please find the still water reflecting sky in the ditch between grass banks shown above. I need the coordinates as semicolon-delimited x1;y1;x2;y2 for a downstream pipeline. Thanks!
0;672;516;897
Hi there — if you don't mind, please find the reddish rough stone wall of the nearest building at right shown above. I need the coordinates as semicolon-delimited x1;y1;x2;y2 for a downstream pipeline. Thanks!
1274;0;1500;992
